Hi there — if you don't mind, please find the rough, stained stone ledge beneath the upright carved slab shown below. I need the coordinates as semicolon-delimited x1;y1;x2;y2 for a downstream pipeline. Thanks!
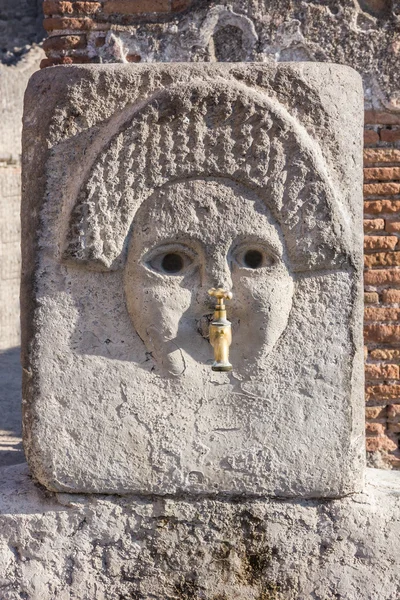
0;466;400;600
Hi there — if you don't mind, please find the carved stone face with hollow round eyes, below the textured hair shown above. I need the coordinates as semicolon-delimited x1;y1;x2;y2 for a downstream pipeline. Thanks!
124;179;294;375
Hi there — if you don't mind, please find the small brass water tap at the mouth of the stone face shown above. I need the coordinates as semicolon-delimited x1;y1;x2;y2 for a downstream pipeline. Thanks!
208;288;232;371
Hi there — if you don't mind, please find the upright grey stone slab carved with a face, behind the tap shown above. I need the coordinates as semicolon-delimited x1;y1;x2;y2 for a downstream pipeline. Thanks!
22;63;363;497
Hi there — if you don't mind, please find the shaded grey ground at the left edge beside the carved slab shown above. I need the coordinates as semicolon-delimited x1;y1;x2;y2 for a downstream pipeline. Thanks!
0;348;25;467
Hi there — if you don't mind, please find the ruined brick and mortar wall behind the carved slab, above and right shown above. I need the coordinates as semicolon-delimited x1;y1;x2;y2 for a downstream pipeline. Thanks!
42;0;400;468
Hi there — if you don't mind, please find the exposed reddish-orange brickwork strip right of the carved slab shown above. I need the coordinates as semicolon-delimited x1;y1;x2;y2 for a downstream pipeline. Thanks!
364;111;400;468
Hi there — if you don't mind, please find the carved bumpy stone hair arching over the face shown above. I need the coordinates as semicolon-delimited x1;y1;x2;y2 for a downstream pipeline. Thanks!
63;80;351;271
